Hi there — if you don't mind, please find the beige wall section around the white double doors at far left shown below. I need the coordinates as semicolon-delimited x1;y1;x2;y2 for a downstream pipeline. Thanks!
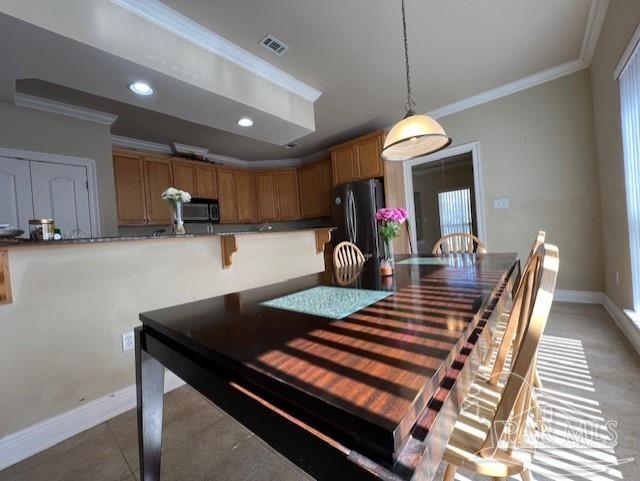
0;102;118;236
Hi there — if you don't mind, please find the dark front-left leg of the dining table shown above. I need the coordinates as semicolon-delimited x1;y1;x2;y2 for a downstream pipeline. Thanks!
135;329;164;481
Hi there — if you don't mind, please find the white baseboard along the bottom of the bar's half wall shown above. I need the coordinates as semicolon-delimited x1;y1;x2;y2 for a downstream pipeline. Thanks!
0;371;184;470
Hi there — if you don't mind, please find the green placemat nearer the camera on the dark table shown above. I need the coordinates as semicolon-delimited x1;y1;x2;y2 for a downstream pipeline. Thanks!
262;286;392;319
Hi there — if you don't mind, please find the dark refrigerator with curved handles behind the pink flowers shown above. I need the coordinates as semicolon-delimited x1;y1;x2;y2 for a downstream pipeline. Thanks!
331;179;384;258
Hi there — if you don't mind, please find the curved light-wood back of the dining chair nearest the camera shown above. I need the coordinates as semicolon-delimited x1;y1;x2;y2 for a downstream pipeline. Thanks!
479;244;559;458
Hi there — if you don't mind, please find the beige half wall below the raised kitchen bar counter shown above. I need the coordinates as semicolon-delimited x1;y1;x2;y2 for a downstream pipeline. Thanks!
0;230;324;438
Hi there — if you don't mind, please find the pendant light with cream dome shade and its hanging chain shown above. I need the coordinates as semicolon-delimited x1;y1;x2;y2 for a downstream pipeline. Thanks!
381;0;451;161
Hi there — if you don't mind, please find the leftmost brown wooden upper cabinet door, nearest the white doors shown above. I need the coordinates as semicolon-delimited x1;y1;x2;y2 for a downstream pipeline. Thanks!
113;152;147;225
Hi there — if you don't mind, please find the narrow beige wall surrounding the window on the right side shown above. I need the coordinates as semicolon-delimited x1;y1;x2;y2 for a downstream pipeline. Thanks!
591;0;640;309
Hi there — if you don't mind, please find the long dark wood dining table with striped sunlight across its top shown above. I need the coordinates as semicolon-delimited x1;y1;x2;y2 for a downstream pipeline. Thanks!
136;254;519;481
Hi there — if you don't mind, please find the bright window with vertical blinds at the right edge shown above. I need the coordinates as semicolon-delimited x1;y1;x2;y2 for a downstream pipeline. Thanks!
620;31;640;311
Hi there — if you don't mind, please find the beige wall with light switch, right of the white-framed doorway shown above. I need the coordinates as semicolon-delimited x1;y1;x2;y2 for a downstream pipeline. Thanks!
394;70;603;291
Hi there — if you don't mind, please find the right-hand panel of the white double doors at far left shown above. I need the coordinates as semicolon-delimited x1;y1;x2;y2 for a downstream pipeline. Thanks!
31;161;92;237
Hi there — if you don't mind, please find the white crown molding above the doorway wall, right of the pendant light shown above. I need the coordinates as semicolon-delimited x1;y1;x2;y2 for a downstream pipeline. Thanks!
427;59;586;119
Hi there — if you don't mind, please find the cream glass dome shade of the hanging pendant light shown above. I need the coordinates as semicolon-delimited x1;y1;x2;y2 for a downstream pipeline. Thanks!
381;115;451;161
